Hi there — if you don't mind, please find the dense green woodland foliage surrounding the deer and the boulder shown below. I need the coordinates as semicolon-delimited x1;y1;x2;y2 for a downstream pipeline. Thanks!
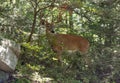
0;0;120;83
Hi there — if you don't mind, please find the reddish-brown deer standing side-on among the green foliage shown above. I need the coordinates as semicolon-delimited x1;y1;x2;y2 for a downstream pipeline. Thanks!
45;21;89;62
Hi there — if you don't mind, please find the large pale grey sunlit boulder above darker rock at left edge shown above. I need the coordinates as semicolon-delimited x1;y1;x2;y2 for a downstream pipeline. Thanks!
0;39;20;72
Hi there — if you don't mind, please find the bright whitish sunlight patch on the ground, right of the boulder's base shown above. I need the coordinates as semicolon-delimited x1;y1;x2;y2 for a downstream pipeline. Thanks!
13;72;54;83
